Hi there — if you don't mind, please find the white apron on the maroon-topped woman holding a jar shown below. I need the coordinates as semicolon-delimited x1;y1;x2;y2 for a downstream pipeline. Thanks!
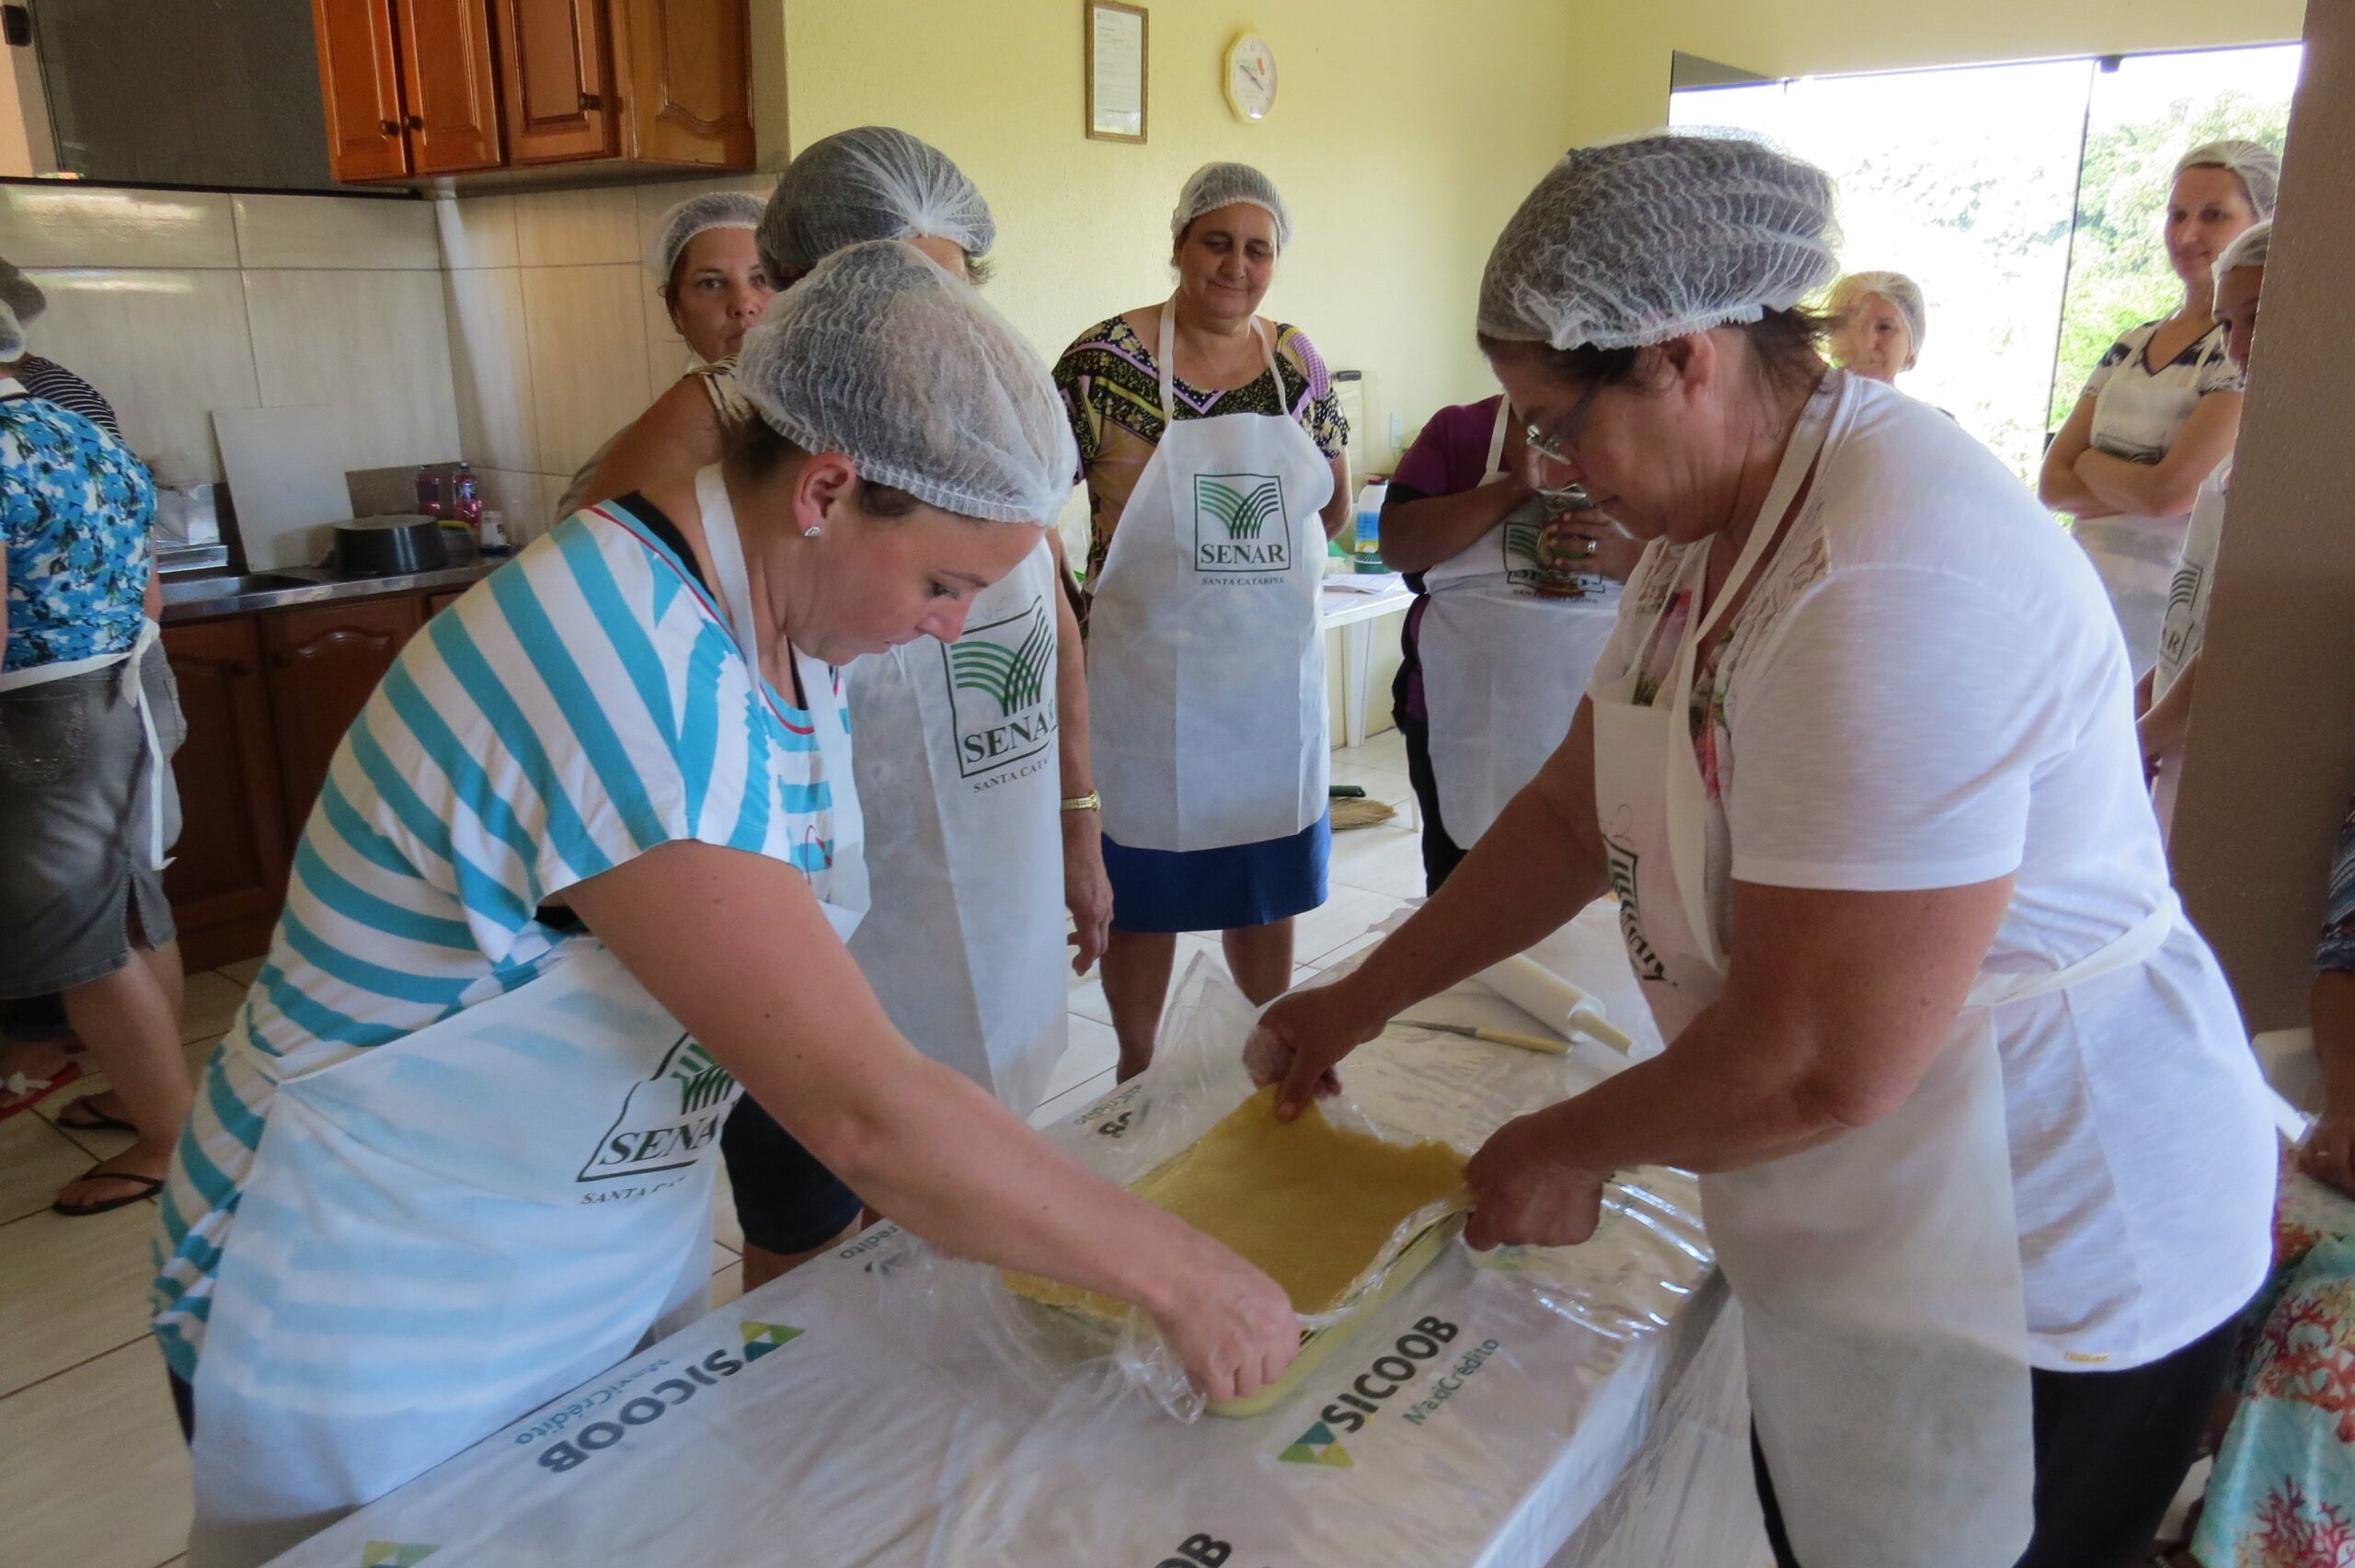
1416;398;1620;850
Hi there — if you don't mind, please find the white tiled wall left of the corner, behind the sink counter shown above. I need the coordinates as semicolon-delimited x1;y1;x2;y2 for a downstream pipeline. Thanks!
0;186;459;489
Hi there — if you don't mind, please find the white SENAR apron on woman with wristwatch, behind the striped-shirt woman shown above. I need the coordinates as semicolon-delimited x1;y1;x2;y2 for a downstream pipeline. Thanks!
845;539;1069;1116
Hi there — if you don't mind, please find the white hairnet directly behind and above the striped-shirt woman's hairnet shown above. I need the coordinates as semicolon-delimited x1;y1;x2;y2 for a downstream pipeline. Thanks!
761;125;998;287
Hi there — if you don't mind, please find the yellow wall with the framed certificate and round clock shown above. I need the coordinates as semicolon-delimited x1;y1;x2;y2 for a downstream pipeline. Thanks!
784;0;1571;466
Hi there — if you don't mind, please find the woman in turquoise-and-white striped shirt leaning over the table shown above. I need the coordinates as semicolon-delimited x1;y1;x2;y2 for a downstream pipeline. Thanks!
155;243;1298;1568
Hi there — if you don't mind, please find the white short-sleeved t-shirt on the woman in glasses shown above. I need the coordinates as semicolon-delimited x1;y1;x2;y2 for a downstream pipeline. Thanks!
1599;372;2275;1368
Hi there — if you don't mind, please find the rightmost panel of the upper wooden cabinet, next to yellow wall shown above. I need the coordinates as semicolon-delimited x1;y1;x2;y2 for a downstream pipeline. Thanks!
617;0;753;169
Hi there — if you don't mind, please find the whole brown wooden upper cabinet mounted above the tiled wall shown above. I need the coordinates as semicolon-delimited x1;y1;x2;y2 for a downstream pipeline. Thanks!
311;0;756;189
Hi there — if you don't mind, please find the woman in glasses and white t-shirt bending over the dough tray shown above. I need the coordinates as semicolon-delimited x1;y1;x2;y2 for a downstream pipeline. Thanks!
1248;134;2275;1568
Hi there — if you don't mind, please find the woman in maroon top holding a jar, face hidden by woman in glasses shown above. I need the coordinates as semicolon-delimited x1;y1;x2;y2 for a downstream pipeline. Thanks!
1383;394;1644;892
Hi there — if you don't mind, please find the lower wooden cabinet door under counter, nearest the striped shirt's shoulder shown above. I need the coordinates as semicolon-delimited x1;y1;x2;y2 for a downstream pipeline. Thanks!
261;596;424;833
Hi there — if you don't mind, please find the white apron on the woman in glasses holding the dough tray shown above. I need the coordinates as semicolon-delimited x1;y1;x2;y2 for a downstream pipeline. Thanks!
1590;372;2178;1568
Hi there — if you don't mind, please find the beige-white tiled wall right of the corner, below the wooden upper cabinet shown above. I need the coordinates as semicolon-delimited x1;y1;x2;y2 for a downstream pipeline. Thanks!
433;174;777;539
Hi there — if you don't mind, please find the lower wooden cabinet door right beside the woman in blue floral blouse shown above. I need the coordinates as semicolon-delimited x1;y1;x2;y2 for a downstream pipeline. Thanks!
163;617;290;970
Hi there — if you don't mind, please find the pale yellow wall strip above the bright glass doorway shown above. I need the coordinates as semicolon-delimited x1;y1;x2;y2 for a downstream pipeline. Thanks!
1564;0;2329;142
